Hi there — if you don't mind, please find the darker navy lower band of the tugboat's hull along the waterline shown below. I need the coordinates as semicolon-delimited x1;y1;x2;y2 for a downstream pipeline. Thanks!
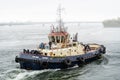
20;55;101;70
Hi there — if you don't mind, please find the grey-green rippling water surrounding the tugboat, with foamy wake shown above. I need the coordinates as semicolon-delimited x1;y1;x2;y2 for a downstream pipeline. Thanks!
0;23;120;80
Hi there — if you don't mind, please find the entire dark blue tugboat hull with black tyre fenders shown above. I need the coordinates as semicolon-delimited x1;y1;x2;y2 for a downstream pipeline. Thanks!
15;46;106;70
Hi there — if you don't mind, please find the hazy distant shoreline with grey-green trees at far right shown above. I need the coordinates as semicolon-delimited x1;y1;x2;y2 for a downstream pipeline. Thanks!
0;20;120;28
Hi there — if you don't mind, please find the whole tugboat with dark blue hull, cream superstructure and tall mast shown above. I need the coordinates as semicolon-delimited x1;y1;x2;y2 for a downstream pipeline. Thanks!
15;5;106;70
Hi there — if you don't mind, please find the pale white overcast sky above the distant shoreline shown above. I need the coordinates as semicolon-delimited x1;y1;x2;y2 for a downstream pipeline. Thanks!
0;0;120;22
